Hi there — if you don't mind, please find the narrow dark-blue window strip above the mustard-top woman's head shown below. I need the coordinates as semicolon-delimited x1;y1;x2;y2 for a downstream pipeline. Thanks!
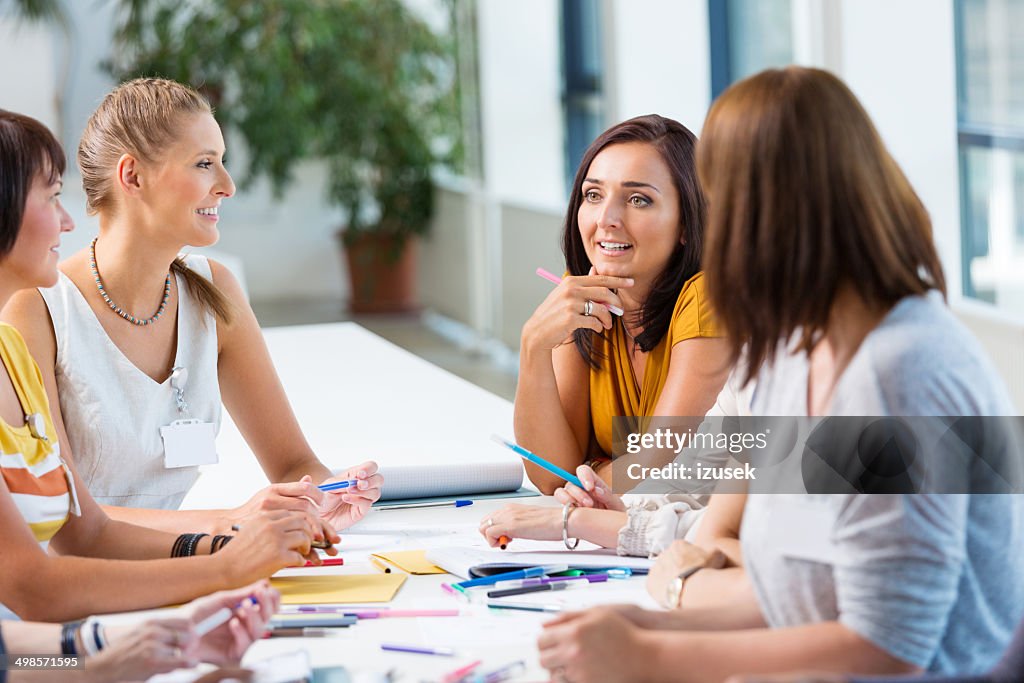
562;0;605;187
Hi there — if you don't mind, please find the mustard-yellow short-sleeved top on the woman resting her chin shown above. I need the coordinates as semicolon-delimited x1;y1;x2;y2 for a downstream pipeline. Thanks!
588;272;725;459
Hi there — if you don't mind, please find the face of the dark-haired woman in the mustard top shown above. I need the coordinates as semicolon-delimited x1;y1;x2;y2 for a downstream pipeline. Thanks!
577;142;682;288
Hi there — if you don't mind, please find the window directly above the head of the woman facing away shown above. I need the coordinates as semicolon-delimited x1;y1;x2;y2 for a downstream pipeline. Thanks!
708;0;793;98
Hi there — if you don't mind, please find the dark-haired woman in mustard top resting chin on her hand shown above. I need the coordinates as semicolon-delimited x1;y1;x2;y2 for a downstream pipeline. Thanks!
484;115;729;546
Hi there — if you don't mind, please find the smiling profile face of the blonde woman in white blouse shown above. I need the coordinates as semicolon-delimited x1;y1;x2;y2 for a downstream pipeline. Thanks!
143;113;234;247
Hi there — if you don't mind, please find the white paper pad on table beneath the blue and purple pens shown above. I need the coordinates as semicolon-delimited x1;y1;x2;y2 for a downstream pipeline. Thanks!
427;547;654;579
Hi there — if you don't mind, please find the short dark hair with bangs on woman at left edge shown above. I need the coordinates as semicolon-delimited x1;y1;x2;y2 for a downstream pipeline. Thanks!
0;110;67;256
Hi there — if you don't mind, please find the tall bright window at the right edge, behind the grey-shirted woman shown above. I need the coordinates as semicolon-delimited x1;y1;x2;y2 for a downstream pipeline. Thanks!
954;0;1024;312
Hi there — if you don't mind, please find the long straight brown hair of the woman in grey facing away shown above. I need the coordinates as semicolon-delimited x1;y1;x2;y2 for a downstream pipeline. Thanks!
697;67;945;382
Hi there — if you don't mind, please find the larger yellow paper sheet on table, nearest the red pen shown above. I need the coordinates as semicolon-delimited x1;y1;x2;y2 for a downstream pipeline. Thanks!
270;572;408;605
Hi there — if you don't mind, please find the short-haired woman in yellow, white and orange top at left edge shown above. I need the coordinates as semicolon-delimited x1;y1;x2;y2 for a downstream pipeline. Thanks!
0;110;319;621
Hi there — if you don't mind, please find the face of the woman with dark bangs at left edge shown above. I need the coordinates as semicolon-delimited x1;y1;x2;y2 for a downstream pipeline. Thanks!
0;173;75;289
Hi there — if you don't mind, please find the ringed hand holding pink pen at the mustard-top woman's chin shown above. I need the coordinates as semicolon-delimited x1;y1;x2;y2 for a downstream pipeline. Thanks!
522;268;633;349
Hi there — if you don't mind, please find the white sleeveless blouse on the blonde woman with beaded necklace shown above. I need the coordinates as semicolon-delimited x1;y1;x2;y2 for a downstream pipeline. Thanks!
39;255;220;510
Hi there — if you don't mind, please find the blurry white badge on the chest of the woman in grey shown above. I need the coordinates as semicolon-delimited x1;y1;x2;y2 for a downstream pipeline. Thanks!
770;495;840;564
